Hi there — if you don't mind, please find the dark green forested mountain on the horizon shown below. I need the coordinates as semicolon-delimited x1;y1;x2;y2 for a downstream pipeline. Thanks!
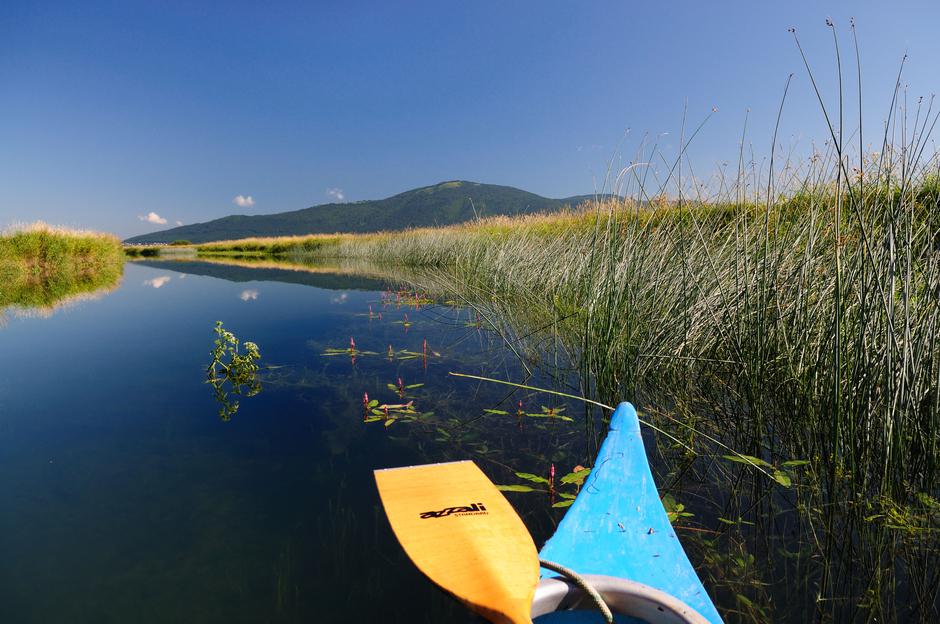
124;180;593;244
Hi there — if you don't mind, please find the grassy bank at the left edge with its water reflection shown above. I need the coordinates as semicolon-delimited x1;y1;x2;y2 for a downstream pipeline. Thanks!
0;223;124;309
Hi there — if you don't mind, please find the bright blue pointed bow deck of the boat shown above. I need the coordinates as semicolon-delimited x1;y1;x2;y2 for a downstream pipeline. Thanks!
538;403;722;624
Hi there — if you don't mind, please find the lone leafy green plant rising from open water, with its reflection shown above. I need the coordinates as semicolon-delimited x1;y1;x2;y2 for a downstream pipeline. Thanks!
206;321;261;421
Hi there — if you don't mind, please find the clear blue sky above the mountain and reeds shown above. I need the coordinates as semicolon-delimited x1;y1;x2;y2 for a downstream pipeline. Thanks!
0;0;940;236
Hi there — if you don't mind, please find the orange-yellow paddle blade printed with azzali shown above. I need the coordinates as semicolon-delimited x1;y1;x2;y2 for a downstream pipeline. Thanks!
375;461;539;624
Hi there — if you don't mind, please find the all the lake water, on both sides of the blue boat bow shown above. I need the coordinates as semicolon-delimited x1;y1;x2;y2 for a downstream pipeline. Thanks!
0;260;940;623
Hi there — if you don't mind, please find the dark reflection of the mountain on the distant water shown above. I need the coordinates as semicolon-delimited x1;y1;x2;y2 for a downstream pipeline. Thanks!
133;258;389;290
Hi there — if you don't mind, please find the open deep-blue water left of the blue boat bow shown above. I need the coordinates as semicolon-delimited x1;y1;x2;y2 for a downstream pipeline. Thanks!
0;263;589;623
